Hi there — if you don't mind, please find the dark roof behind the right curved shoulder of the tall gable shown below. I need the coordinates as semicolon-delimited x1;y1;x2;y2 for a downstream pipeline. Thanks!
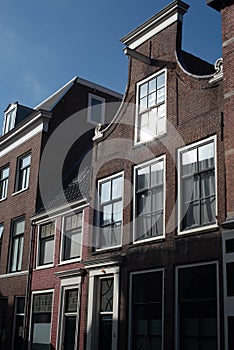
177;50;215;76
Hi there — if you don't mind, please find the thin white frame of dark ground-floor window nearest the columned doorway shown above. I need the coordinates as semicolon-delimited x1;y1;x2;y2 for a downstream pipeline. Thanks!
128;268;164;350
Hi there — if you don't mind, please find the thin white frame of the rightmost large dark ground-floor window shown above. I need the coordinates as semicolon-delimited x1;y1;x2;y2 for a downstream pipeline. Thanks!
175;261;220;350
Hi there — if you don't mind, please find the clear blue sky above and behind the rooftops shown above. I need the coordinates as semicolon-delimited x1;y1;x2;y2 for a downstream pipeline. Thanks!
0;0;222;130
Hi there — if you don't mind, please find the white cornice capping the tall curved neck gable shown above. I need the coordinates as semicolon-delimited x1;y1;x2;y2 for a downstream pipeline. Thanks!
120;0;189;50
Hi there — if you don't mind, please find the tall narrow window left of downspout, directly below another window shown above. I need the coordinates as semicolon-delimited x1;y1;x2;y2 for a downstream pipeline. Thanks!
10;218;25;272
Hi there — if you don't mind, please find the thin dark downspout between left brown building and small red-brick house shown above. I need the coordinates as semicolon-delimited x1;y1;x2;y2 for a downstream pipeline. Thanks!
23;223;36;350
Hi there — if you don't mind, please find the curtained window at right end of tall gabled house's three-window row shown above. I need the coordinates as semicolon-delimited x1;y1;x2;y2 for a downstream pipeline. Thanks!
179;138;216;231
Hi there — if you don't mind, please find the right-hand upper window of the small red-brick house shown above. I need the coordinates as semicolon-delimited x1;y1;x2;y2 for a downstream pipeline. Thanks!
62;212;83;260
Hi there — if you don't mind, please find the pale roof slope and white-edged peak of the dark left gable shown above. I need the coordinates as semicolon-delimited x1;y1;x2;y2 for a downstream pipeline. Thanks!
35;76;122;111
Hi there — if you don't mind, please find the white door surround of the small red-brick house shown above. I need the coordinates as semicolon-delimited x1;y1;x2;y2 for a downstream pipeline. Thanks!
57;276;81;350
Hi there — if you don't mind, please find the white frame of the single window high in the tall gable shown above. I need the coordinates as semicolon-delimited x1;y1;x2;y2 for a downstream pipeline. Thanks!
134;69;167;144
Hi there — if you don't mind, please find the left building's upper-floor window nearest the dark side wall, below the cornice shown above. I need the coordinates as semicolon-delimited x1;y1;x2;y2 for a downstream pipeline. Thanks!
16;154;31;191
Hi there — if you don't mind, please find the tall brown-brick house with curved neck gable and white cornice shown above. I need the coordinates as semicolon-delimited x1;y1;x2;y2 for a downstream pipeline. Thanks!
84;0;231;350
